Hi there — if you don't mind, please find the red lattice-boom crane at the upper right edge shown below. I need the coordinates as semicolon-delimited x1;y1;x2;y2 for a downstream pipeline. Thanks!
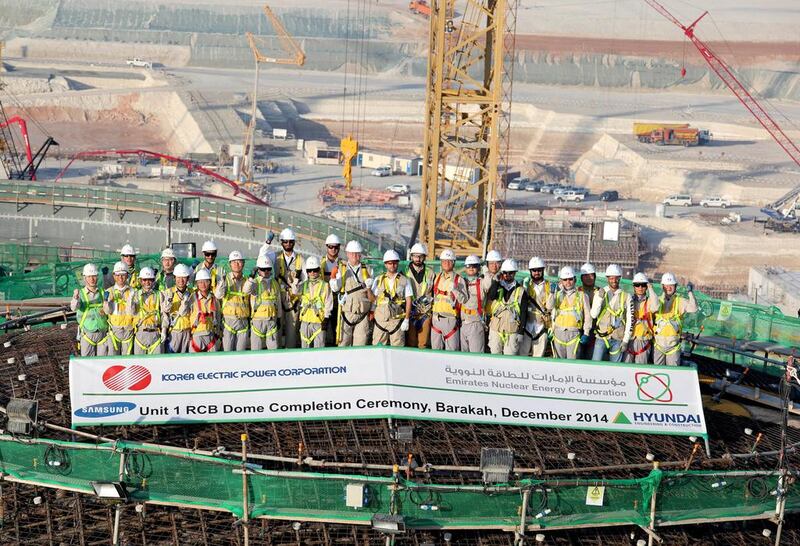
644;0;800;217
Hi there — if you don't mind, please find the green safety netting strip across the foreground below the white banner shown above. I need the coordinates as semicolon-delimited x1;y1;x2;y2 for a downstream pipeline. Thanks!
0;435;800;528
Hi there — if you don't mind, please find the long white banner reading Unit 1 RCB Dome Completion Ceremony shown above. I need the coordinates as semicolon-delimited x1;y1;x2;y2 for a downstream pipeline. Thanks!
70;347;706;437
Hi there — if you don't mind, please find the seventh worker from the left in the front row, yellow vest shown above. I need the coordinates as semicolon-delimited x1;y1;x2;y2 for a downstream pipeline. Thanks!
244;255;283;351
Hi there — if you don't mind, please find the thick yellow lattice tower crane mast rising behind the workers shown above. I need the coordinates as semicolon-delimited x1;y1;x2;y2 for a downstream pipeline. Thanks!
417;0;518;256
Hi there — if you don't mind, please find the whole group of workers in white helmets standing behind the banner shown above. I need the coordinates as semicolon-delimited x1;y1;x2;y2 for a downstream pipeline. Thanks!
71;228;697;366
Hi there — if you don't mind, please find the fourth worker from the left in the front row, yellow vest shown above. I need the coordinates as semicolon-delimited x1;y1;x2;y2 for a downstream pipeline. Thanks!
161;264;194;353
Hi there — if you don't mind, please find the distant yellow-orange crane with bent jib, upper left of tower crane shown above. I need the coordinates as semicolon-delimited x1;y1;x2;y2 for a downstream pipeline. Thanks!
240;5;306;187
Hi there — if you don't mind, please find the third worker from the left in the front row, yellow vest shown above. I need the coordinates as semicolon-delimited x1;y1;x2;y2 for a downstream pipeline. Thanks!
133;267;167;355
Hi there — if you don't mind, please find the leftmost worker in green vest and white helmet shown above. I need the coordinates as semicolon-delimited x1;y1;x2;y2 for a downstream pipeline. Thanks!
69;264;108;356
